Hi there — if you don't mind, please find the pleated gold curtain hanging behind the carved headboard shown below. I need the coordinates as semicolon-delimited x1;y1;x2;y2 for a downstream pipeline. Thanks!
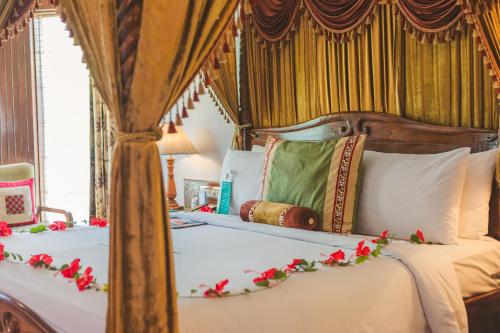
246;5;499;128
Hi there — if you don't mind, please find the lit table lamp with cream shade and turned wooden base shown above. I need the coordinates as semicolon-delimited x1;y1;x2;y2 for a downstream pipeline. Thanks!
157;125;196;209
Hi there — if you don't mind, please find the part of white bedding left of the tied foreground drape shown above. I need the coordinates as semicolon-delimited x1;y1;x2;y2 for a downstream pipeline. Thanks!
0;227;109;333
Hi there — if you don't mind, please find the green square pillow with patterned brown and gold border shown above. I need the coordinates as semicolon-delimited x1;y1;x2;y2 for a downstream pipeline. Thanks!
262;135;366;233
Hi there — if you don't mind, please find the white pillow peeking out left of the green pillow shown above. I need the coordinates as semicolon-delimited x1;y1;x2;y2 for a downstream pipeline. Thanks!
221;149;264;215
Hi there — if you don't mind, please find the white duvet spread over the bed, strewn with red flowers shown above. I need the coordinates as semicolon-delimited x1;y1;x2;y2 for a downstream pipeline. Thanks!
0;213;467;332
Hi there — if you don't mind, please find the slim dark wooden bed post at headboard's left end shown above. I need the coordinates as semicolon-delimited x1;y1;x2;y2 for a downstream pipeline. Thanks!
239;16;252;150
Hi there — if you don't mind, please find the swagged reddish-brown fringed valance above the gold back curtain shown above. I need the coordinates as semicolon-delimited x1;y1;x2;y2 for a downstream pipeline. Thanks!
245;0;498;42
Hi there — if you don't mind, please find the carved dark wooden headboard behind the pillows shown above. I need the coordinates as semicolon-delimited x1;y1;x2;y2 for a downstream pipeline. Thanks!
250;112;500;239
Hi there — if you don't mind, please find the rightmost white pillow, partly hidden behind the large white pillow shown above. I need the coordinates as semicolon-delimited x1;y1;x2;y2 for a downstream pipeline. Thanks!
458;149;498;239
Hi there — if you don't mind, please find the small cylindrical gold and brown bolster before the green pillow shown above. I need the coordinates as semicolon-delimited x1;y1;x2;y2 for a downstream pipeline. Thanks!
240;200;317;230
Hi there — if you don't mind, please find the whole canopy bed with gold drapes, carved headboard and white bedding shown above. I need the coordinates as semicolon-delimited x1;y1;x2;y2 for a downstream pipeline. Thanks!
0;0;500;332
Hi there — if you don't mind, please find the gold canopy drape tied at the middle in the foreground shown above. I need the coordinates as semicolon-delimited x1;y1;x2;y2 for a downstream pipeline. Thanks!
60;0;237;332
